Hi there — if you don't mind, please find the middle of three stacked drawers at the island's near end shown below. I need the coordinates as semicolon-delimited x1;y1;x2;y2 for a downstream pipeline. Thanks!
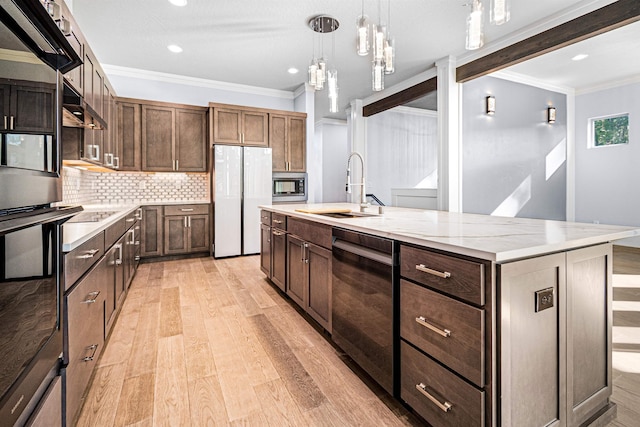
400;280;485;387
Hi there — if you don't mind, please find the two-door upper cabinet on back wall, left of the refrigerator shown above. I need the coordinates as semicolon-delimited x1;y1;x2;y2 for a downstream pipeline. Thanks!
141;104;207;172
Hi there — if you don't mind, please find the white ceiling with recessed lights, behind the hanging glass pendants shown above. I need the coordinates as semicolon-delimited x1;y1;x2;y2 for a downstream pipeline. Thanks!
72;0;640;119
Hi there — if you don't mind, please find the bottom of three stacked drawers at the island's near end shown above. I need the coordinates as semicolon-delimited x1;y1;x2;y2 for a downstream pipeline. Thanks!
400;341;485;427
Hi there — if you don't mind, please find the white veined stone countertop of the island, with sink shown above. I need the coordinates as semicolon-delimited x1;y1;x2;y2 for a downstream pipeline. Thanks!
261;203;640;263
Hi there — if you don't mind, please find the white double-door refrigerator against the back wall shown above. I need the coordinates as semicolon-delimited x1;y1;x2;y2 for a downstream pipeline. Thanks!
212;145;271;258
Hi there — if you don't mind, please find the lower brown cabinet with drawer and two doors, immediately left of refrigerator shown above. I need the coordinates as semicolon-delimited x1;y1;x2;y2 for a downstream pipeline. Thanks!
163;205;209;255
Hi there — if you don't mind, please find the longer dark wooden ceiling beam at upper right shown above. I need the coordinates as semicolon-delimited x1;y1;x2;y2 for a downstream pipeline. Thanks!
458;0;640;83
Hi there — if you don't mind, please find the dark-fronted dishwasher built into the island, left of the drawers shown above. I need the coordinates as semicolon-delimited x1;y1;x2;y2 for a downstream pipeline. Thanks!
332;228;399;395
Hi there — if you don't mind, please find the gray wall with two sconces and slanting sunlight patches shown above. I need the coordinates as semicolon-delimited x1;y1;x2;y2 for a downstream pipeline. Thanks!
462;77;567;220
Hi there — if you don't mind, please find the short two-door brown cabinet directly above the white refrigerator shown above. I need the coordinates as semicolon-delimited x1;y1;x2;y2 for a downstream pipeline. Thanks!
210;104;269;147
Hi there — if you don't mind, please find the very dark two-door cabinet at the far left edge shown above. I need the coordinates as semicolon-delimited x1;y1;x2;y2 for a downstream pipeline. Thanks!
0;79;56;135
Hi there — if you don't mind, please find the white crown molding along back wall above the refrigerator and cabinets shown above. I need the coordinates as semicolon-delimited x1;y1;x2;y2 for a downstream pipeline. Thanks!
101;64;294;99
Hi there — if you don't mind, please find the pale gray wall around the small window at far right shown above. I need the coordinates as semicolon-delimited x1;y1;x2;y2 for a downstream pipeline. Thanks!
575;83;640;231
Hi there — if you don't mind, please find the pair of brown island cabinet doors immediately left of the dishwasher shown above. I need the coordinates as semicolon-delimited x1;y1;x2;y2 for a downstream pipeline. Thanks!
286;234;331;332
